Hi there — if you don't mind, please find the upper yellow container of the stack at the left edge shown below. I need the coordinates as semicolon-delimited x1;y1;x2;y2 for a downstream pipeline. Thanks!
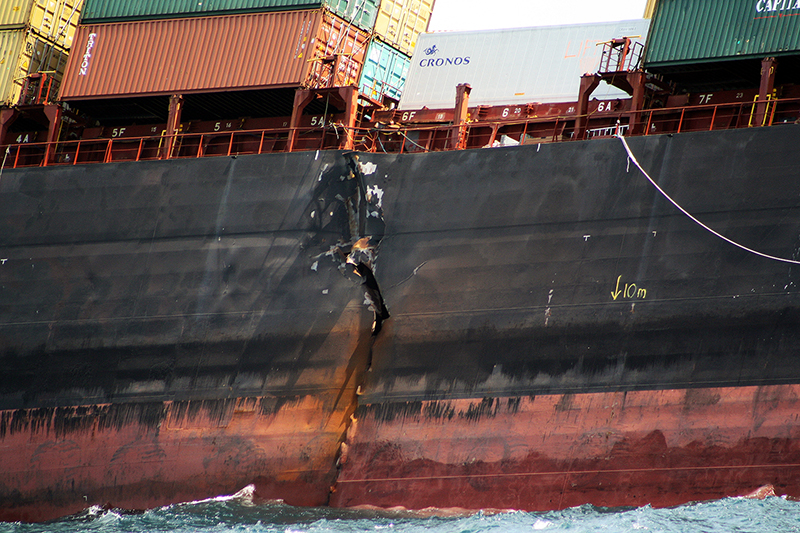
0;0;83;50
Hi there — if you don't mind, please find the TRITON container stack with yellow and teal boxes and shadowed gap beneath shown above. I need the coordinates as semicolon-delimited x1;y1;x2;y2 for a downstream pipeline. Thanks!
61;0;433;122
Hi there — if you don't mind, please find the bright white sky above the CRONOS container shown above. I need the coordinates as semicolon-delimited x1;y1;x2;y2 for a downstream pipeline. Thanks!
428;0;647;31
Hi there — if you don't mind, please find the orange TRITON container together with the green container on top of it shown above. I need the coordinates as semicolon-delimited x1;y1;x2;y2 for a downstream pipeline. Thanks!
63;0;378;100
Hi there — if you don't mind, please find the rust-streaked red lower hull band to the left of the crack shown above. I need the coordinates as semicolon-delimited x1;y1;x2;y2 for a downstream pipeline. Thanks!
0;391;353;521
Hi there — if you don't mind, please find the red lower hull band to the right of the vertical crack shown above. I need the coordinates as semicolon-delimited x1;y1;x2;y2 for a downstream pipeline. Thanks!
332;386;800;511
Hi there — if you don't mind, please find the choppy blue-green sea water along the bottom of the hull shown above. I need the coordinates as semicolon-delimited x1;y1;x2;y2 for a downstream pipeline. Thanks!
0;495;800;533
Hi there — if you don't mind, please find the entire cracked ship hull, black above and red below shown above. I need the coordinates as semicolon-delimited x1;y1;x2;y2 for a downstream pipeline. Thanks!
0;125;800;520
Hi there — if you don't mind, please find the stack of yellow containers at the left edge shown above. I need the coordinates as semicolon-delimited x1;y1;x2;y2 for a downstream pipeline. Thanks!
0;0;83;107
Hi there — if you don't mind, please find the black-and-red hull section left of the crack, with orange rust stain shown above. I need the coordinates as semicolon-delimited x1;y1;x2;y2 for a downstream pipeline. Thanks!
0;149;378;521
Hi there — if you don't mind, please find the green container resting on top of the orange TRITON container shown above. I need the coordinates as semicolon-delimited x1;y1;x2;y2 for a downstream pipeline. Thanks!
81;0;380;31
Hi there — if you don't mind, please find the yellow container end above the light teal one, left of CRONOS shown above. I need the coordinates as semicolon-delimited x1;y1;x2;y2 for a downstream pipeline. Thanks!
375;0;435;55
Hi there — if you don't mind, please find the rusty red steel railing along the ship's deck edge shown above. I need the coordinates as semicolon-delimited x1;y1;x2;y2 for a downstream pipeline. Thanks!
0;99;800;168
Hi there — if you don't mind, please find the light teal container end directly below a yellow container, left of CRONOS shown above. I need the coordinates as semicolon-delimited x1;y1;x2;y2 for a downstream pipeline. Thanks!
358;38;411;101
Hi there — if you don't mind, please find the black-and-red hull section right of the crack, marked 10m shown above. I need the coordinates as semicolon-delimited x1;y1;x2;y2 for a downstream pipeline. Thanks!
333;127;800;510
